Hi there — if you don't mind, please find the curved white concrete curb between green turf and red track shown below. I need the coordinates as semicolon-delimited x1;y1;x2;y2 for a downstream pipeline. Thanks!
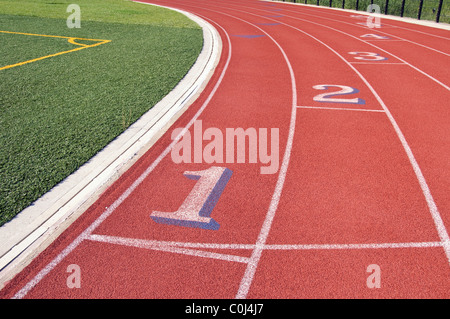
0;1;222;289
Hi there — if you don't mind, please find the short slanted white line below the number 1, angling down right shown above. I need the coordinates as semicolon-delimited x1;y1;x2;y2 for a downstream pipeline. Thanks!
86;235;249;263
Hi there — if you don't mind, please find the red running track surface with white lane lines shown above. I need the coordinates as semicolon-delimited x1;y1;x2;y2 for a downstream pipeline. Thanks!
0;0;450;298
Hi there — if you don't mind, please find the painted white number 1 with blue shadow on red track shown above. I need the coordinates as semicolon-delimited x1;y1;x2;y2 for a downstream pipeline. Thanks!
150;166;233;230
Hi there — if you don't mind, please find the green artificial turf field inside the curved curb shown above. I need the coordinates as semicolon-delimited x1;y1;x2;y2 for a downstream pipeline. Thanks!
0;0;203;225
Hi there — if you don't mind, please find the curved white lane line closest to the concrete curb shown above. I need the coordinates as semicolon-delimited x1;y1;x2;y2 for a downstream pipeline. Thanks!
13;15;232;299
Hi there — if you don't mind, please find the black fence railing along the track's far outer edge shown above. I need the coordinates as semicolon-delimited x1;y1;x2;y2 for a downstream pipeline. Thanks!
282;0;450;23
